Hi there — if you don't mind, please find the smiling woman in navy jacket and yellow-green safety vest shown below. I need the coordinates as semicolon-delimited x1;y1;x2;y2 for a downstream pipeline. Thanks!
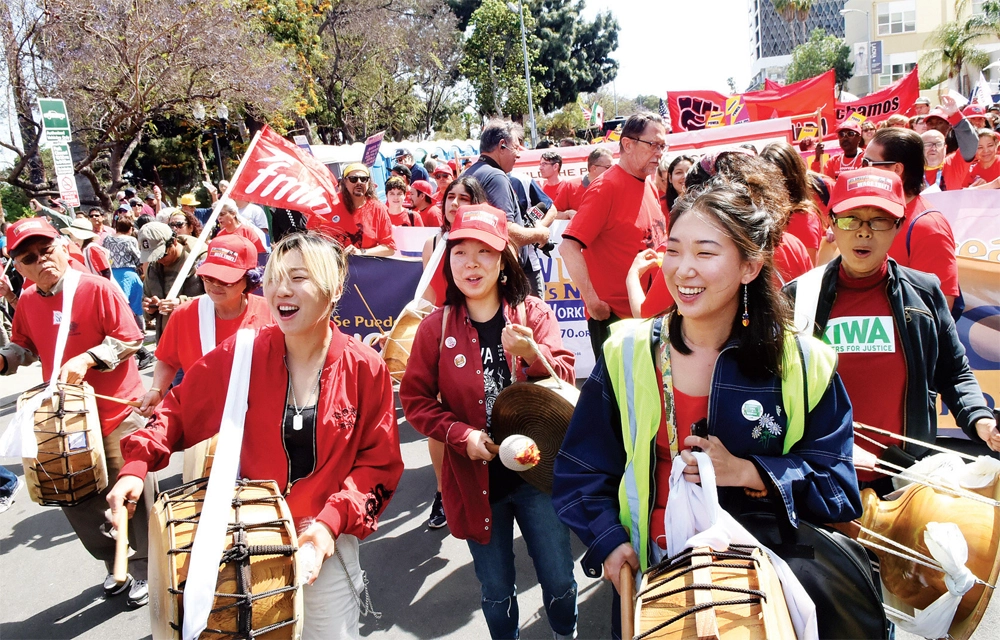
552;178;861;634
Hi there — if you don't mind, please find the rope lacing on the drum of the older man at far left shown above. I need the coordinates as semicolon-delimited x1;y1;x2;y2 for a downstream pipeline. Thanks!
28;383;98;507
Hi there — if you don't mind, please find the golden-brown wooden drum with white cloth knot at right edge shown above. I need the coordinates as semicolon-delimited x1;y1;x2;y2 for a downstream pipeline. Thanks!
858;482;1000;640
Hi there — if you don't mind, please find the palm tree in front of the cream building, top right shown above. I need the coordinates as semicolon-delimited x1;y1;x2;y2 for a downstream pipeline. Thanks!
920;0;995;94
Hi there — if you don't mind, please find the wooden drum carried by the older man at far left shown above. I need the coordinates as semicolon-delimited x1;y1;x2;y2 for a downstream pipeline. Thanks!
17;383;108;507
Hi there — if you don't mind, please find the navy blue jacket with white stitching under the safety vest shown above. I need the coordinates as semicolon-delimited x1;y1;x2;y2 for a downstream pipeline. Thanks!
552;320;861;577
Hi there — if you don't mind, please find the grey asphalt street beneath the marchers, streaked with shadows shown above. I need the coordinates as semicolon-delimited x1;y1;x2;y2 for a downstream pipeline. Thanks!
0;364;1000;640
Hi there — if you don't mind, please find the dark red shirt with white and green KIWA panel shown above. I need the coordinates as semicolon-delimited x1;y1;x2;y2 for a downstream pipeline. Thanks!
823;265;906;482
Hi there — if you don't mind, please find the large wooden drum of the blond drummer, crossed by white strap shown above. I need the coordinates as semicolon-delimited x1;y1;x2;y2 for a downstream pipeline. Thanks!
149;478;302;640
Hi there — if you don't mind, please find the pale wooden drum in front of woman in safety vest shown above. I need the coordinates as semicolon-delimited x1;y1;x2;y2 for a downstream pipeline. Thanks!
635;545;795;640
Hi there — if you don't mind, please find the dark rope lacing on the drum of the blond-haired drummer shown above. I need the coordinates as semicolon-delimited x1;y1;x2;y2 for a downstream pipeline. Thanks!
165;480;298;640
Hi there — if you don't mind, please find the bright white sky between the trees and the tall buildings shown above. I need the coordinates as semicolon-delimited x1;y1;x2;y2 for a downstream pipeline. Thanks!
584;0;751;98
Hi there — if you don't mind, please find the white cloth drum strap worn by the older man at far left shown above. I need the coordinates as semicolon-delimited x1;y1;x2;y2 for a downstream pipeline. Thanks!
0;269;80;459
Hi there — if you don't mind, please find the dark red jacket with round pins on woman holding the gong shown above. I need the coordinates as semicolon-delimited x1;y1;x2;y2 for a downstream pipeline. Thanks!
399;297;576;544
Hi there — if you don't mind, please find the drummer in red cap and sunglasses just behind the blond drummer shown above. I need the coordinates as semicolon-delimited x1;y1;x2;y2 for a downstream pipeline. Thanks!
139;235;274;417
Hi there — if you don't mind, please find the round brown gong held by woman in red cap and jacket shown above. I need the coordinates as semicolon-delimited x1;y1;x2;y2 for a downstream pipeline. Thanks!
490;377;580;493
